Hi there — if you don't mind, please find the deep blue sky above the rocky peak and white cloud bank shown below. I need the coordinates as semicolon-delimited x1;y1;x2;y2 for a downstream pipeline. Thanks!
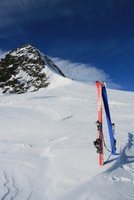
0;0;134;91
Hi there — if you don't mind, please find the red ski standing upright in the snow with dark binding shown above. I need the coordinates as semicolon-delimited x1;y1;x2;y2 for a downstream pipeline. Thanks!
96;81;104;166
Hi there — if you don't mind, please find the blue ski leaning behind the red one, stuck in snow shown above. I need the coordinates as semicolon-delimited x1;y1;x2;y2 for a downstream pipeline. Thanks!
102;83;116;155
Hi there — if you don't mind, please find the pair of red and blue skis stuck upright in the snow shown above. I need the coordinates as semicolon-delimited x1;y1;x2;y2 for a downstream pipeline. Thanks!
94;81;116;166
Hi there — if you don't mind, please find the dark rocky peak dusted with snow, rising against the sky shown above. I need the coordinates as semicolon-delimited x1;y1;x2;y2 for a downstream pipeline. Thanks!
0;44;64;93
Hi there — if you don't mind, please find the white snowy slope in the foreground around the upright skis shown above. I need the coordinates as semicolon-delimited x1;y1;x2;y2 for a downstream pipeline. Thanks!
0;75;134;200
